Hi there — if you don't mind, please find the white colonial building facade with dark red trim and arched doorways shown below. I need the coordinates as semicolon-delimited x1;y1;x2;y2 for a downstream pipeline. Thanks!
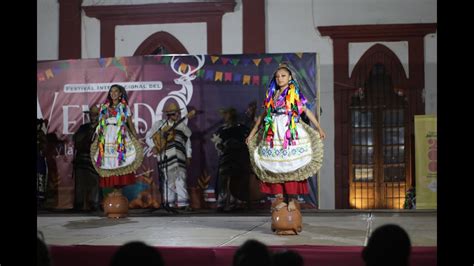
37;0;437;209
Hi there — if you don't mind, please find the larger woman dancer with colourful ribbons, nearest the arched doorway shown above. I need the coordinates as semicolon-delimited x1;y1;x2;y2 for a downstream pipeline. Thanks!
246;64;326;234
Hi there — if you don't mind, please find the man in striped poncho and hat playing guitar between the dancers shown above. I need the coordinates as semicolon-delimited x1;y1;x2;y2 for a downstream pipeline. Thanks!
145;103;192;210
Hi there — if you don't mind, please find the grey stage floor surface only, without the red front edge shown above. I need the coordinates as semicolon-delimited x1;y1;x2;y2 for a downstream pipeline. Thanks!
37;210;437;247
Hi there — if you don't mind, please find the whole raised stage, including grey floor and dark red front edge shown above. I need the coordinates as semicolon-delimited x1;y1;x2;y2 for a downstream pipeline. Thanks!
37;209;437;266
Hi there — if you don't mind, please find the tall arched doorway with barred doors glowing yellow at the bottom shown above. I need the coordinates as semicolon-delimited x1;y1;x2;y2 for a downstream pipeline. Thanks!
347;44;411;209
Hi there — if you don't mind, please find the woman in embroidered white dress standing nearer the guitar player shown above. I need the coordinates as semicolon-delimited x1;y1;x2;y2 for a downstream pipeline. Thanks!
91;84;143;204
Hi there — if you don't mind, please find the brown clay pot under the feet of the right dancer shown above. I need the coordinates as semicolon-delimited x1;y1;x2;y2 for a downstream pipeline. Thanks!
272;206;303;235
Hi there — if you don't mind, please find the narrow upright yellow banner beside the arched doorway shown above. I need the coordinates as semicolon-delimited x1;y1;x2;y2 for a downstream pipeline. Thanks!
415;115;438;209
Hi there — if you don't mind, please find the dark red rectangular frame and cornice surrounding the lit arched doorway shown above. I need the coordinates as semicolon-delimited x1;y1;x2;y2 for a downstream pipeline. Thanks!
318;23;437;209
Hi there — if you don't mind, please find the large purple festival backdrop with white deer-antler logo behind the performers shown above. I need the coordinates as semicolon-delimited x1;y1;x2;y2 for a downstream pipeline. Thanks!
37;53;319;209
